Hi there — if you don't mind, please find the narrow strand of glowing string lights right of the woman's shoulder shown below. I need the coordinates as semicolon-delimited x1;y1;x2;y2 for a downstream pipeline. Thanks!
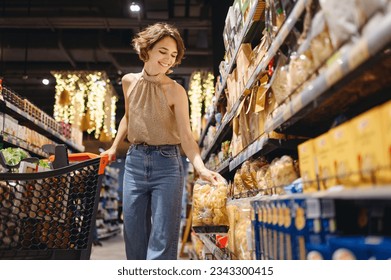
189;71;214;138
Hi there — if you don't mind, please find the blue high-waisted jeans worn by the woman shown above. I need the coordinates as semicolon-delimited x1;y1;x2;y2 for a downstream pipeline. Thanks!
123;144;183;260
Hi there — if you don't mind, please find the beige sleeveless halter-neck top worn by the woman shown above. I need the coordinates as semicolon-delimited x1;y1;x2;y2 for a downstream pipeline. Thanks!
128;70;180;145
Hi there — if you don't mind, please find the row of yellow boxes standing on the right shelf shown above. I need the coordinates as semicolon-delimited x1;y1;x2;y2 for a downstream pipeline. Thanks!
298;102;391;192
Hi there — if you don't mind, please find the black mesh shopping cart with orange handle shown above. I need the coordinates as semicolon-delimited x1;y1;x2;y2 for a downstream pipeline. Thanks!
0;153;108;260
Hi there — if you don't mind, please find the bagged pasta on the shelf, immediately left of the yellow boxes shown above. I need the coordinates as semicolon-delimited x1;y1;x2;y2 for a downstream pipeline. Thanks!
270;156;298;190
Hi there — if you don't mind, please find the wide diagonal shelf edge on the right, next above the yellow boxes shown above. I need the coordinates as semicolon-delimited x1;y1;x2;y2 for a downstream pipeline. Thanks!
265;10;391;132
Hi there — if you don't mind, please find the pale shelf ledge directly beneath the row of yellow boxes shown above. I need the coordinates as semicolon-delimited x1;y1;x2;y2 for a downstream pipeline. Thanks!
312;185;391;200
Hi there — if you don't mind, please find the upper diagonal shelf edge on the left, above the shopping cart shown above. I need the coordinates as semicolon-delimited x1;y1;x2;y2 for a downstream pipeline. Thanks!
0;101;85;152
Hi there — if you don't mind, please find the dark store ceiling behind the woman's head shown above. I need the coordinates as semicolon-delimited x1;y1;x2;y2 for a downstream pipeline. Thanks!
0;0;232;125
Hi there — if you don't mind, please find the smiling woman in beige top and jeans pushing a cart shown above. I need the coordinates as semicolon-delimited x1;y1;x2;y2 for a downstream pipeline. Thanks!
103;23;222;259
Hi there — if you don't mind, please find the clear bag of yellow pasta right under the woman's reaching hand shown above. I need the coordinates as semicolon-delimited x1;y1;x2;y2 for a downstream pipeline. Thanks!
193;180;228;226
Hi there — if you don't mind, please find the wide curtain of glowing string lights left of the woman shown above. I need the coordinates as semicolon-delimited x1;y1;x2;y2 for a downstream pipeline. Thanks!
52;71;117;139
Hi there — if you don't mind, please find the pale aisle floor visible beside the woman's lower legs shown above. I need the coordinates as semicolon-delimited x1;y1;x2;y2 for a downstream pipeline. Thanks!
90;225;188;260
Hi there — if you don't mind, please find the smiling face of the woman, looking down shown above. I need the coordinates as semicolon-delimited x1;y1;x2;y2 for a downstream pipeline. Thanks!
145;37;178;74
